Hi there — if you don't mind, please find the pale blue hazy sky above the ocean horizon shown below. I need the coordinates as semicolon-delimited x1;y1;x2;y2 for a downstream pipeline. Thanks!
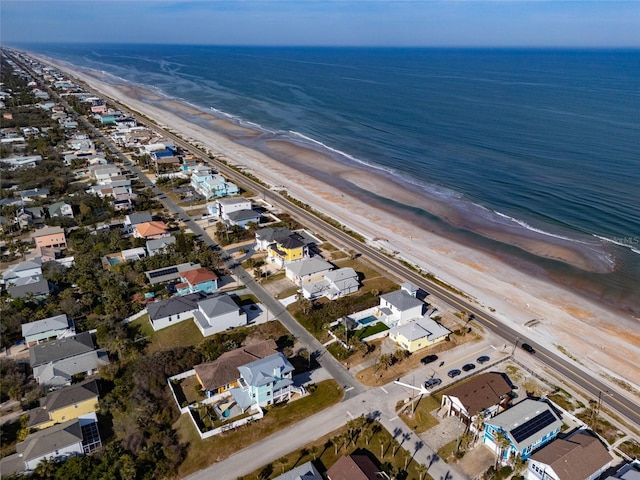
0;0;640;47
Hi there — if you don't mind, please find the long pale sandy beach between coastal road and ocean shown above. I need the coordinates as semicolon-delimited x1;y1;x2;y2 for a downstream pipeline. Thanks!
46;58;640;394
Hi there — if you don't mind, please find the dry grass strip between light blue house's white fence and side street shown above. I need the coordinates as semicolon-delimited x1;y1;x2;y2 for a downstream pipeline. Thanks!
174;380;343;477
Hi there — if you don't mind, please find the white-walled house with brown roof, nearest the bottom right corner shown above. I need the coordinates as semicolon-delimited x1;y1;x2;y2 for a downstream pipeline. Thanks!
525;430;613;480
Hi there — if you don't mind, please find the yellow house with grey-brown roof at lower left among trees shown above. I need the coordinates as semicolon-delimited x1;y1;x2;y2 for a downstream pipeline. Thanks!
27;380;100;430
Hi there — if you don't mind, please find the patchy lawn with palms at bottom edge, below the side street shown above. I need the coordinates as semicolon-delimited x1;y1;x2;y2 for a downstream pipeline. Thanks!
238;422;432;480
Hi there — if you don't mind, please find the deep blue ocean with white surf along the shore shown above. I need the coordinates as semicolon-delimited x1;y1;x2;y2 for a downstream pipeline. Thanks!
16;44;640;315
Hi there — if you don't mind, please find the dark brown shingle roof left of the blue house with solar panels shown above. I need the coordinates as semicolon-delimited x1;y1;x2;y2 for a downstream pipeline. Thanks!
446;372;511;417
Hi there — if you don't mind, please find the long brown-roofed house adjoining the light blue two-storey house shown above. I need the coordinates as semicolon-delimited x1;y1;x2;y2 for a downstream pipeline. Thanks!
193;339;278;397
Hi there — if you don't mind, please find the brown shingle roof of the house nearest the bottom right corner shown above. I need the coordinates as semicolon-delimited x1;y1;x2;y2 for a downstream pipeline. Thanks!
531;431;613;480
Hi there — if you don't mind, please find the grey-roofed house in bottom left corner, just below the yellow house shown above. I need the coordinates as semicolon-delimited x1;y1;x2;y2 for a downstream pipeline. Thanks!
0;413;102;477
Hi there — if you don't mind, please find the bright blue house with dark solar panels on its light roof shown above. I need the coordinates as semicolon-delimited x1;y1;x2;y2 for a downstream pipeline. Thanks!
483;398;562;462
